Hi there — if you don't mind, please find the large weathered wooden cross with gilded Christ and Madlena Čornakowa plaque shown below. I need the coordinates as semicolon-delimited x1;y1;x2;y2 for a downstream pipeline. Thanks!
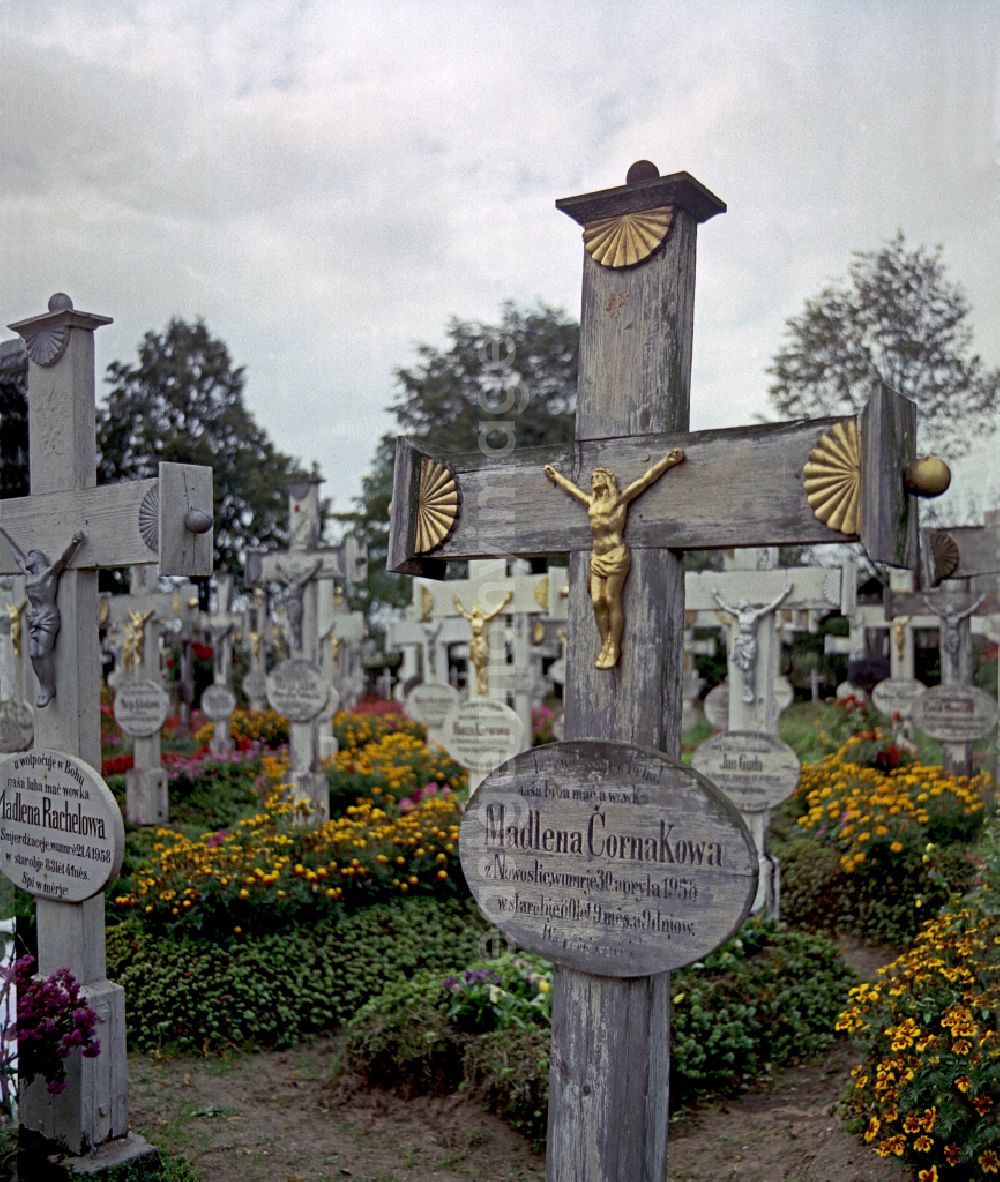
388;162;945;1182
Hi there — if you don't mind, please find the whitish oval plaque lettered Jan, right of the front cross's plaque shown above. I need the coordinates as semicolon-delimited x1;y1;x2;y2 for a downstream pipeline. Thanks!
691;730;801;812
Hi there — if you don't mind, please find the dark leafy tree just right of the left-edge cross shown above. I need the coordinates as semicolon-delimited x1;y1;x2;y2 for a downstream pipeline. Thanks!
97;320;312;581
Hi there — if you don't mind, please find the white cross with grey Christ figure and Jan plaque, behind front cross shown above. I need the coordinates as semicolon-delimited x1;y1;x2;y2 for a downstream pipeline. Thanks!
684;547;856;917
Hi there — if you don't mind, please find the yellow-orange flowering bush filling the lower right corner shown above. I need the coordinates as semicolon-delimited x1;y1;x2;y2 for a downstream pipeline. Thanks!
837;820;1000;1182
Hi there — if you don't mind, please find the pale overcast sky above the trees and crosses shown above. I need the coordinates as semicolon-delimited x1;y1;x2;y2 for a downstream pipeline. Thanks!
0;0;1000;527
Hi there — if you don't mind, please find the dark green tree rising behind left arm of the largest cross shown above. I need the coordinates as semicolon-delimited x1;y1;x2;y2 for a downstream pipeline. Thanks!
356;303;579;609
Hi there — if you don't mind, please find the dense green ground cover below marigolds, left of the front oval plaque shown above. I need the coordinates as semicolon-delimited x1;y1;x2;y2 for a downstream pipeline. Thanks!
108;898;485;1053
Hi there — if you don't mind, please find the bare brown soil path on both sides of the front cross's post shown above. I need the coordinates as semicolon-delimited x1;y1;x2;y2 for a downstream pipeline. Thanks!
130;942;905;1182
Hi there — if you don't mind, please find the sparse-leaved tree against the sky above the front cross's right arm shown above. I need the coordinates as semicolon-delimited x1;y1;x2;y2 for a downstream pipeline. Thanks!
768;230;1000;456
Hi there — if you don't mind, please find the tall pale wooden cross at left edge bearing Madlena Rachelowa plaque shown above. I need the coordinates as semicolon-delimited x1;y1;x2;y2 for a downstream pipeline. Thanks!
0;294;212;1157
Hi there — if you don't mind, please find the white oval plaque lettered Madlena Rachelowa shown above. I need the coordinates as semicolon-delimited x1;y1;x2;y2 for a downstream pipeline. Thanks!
0;748;125;903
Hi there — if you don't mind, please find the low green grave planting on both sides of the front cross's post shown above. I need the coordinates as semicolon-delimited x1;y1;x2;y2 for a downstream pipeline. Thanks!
348;920;852;1137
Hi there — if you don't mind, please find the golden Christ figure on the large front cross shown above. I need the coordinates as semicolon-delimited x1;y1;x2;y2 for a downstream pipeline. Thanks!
545;447;684;669
